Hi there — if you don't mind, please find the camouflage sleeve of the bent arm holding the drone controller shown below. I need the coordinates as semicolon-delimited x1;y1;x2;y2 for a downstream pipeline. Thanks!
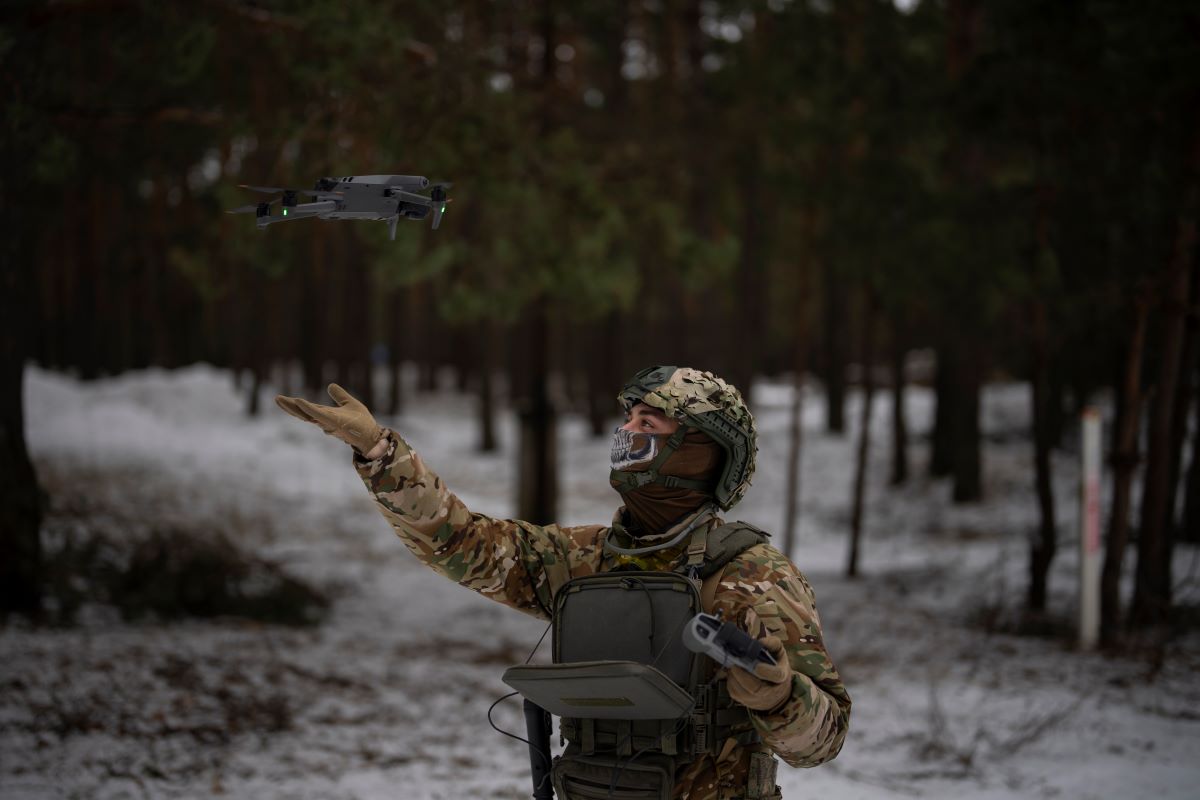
715;545;850;766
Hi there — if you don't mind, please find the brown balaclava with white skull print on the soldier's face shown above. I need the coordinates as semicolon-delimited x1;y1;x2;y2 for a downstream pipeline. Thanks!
612;428;725;536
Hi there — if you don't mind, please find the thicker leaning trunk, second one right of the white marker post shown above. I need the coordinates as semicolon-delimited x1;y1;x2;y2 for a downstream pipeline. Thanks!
1133;205;1195;625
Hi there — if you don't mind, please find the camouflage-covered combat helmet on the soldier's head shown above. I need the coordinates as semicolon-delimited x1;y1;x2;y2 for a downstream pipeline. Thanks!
617;367;757;510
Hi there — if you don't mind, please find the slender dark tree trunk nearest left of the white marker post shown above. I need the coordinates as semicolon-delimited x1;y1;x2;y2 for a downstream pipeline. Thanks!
1028;301;1058;612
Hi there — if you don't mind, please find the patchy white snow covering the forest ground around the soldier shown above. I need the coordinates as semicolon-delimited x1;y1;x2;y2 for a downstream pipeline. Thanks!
0;366;1200;800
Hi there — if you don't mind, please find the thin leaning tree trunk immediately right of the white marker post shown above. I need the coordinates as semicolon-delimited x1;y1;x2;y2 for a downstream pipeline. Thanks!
1100;297;1148;645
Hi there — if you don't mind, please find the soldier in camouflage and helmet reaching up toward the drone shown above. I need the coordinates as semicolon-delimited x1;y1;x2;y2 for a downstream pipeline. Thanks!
276;367;851;800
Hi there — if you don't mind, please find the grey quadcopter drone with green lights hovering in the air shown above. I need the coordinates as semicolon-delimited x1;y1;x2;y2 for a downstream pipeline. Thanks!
229;175;451;240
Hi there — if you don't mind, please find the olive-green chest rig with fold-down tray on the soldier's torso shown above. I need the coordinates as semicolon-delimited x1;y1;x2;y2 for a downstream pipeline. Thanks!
504;522;767;800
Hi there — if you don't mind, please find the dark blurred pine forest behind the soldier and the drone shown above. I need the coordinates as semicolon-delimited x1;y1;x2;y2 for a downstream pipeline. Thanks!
0;0;1200;662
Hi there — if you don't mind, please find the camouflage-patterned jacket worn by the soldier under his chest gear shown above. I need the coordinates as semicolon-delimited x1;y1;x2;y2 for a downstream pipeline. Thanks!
355;432;850;800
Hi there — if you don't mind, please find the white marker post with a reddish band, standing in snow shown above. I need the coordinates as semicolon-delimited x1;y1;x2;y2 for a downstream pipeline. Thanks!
1079;407;1100;650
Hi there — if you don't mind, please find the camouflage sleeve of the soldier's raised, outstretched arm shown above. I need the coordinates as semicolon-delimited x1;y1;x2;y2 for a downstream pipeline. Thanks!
354;431;605;619
